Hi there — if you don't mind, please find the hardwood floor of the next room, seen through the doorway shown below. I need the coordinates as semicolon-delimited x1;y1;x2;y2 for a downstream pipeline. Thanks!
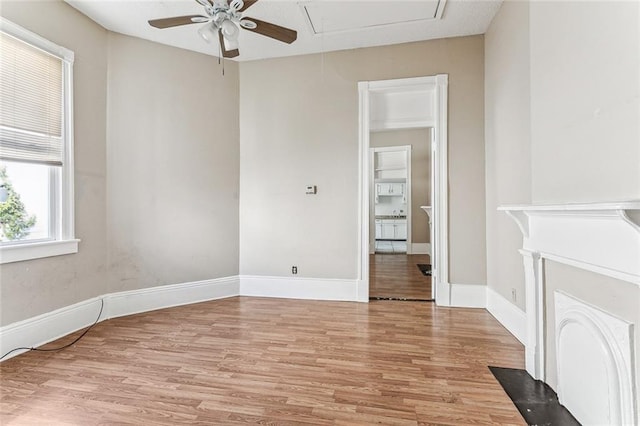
369;254;433;300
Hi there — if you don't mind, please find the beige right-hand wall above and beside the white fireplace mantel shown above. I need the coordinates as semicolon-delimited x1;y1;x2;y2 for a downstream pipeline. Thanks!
485;1;640;309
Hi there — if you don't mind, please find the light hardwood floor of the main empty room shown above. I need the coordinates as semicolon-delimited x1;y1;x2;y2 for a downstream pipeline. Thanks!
0;297;525;425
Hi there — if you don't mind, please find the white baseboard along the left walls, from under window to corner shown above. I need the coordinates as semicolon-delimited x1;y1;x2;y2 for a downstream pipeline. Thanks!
0;276;240;361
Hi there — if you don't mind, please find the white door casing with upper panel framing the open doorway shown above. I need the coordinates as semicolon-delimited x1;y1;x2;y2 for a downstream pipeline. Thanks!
357;74;450;306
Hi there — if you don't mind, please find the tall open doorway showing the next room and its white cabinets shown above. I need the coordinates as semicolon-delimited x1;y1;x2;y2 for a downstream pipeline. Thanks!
369;128;433;301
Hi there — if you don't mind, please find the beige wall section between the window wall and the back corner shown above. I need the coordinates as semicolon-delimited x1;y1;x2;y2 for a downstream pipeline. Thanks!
107;33;239;291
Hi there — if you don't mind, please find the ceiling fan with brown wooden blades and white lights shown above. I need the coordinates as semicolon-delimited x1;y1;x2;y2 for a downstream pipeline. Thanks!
149;0;298;58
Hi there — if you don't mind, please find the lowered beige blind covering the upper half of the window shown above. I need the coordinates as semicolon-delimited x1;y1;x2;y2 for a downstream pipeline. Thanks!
0;31;64;166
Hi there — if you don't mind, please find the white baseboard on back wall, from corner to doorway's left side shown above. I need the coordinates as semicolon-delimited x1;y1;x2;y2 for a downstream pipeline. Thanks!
240;275;358;302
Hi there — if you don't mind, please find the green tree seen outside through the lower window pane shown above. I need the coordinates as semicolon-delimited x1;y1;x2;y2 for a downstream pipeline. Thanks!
0;167;36;241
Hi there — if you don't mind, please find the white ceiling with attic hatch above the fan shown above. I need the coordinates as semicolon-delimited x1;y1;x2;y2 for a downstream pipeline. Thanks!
65;0;502;61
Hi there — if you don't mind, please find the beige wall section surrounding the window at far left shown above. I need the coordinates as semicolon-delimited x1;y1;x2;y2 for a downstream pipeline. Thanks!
0;1;107;325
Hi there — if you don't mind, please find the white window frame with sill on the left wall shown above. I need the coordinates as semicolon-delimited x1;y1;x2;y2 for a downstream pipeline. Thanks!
0;17;80;264
